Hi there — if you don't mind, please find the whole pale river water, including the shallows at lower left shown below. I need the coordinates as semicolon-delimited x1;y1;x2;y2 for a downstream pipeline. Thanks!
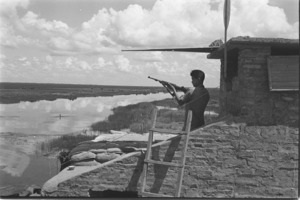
0;93;169;195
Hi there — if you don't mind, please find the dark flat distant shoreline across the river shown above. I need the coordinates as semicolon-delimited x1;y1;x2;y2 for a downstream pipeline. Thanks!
0;82;166;104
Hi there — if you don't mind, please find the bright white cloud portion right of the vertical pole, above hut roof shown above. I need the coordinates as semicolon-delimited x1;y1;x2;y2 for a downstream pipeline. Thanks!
229;0;298;38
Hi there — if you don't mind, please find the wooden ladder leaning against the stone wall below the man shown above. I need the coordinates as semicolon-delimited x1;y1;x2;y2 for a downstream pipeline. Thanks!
141;110;192;197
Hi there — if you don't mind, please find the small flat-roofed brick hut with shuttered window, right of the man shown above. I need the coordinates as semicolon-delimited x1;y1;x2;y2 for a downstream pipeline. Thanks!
207;37;299;126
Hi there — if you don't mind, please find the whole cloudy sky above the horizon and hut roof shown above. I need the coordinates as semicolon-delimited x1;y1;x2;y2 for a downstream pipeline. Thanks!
0;0;299;87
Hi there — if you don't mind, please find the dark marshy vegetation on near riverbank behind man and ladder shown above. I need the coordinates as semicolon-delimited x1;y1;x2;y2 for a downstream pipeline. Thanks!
43;88;219;151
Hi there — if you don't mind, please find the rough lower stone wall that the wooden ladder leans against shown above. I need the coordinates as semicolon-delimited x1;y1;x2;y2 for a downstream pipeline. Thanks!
46;125;299;198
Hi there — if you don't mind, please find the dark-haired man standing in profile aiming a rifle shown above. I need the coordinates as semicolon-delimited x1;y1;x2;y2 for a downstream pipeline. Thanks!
166;70;210;130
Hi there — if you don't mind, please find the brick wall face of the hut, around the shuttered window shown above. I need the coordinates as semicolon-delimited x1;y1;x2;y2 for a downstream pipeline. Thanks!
220;46;299;126
